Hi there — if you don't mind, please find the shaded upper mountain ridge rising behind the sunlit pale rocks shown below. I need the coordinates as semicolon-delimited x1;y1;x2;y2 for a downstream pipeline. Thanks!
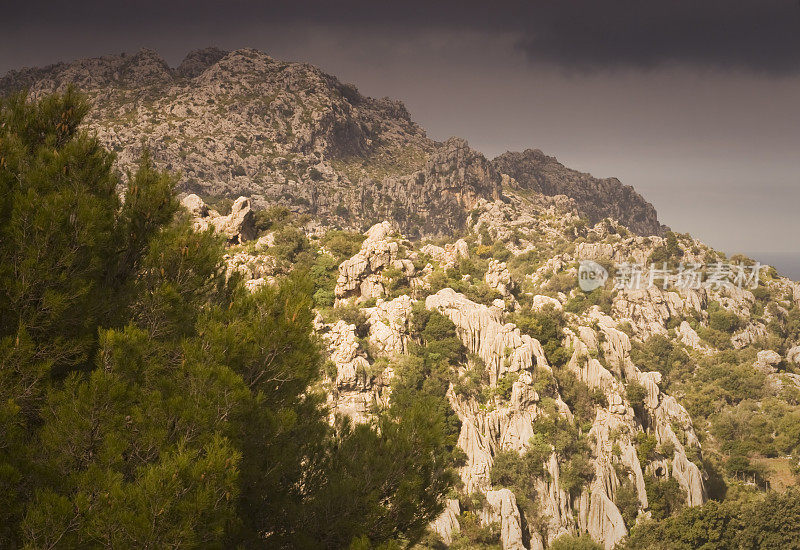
0;48;664;240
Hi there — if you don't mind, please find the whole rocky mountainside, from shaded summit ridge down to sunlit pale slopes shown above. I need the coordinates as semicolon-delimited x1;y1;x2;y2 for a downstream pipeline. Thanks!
0;49;800;550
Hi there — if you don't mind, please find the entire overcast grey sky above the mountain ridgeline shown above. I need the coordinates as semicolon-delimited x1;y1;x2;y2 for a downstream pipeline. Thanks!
0;0;800;277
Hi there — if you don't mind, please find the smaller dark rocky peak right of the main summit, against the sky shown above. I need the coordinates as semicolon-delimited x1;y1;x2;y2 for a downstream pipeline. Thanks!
492;149;666;235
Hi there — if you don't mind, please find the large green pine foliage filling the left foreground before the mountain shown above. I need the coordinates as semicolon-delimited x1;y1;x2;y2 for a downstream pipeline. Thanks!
0;91;456;548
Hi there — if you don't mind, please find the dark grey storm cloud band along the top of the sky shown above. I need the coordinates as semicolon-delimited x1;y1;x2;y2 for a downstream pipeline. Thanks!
0;0;800;74
